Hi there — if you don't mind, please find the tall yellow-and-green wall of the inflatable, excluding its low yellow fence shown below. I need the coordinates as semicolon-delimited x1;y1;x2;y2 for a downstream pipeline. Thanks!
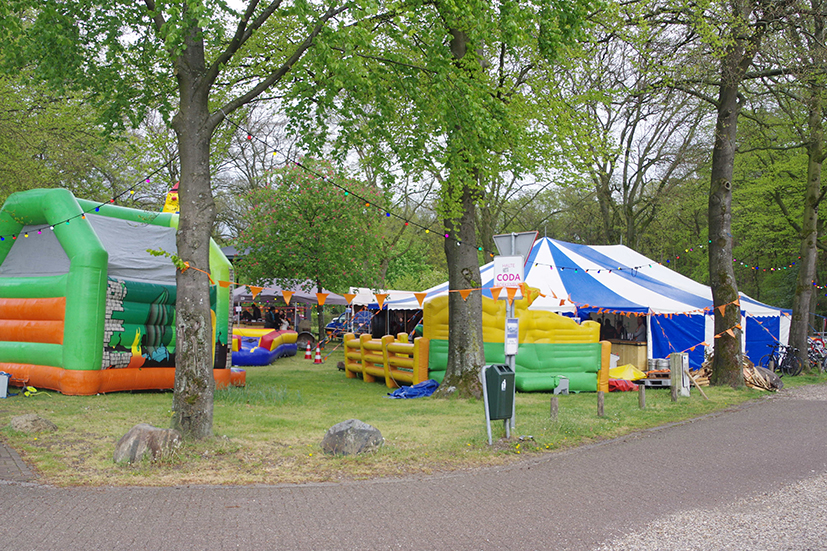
423;288;611;392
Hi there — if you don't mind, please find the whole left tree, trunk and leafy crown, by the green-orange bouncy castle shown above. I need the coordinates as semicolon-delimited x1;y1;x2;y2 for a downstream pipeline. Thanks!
0;0;352;438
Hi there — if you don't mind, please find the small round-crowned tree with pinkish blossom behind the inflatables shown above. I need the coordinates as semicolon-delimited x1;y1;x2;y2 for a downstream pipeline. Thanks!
236;159;384;335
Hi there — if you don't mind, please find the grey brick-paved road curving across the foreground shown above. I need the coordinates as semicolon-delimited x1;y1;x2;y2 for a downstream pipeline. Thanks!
0;386;827;551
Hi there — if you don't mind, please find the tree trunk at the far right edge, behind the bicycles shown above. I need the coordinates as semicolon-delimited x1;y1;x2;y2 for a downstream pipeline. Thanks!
790;2;825;369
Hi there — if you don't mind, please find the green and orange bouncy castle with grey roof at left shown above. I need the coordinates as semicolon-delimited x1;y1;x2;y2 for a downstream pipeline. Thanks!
0;189;244;395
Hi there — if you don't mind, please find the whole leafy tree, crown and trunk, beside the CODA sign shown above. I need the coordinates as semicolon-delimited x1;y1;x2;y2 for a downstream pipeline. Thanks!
286;0;594;396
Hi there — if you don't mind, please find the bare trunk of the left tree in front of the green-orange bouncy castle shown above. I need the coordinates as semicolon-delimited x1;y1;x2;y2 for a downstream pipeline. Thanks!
172;27;215;439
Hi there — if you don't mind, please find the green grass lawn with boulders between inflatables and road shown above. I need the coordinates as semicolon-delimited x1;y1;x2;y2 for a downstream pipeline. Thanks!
0;351;823;485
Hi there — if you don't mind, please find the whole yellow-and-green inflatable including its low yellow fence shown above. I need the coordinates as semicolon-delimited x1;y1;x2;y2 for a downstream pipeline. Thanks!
344;288;611;392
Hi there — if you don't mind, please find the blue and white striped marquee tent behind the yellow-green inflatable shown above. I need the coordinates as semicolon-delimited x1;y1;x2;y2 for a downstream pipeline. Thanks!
388;237;790;367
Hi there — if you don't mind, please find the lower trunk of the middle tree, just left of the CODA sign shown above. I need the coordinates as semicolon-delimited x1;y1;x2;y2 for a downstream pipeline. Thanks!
437;184;485;398
